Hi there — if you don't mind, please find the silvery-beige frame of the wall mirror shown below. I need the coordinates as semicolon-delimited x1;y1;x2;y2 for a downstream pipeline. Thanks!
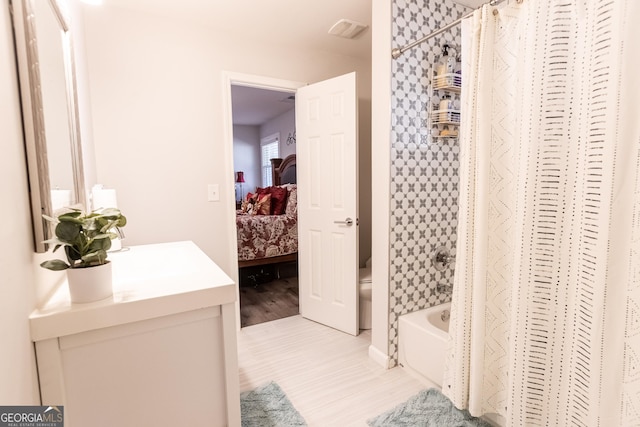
10;0;86;253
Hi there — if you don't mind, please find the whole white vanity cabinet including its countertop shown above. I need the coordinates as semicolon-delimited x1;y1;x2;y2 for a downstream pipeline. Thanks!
30;242;240;427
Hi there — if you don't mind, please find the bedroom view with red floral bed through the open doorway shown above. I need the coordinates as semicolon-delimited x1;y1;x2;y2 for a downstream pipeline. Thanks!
231;84;300;327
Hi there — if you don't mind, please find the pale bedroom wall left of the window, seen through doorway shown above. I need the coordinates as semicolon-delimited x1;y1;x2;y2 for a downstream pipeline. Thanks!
233;125;261;196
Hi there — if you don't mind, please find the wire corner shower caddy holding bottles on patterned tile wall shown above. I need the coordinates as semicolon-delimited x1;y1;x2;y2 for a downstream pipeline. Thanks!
428;49;462;142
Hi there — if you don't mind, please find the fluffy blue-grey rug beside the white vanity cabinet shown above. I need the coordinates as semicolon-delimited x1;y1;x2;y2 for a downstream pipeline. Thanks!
240;381;307;427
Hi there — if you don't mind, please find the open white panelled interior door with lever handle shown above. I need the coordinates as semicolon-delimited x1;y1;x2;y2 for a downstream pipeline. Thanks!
296;73;359;335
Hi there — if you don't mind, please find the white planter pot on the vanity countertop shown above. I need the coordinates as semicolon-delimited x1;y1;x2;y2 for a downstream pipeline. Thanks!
67;261;113;303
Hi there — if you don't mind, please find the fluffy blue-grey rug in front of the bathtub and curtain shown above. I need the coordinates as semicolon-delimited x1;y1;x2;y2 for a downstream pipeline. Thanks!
367;388;491;427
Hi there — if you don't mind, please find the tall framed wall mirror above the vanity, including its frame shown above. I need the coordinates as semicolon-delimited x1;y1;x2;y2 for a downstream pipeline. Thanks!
11;0;86;252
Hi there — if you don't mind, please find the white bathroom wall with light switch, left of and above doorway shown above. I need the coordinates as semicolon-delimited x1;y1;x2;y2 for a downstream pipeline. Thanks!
84;2;371;275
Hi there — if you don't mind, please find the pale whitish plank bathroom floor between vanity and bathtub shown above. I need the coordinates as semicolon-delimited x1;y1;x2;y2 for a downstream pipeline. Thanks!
238;315;430;427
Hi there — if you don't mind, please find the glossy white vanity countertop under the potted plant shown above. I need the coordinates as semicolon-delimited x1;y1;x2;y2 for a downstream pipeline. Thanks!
29;241;236;341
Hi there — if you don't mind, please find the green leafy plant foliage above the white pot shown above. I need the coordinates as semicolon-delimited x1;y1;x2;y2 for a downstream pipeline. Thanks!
40;208;127;271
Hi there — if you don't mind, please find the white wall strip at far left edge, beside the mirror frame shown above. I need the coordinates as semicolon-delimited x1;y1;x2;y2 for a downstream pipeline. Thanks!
0;4;40;405
